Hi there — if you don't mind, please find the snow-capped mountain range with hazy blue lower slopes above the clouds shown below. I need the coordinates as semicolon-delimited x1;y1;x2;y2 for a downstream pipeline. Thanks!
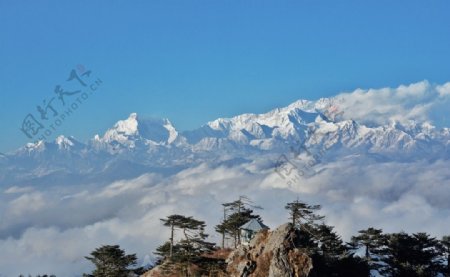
0;98;450;186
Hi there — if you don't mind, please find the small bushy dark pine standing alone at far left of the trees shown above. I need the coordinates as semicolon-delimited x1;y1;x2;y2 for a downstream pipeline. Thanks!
84;245;137;277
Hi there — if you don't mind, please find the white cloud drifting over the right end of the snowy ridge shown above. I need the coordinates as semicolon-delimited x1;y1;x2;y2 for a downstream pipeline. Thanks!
336;81;450;125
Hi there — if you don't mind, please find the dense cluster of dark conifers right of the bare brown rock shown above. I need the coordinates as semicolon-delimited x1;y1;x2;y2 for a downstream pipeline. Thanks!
285;200;450;277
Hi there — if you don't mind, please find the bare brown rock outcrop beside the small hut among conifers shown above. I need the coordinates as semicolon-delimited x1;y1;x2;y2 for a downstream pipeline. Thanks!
226;224;312;277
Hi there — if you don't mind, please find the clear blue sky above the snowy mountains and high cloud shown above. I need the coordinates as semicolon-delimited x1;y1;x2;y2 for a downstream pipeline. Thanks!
0;0;450;152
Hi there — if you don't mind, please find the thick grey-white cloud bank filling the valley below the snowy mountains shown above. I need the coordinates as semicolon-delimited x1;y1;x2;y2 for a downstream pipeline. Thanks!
0;157;450;276
